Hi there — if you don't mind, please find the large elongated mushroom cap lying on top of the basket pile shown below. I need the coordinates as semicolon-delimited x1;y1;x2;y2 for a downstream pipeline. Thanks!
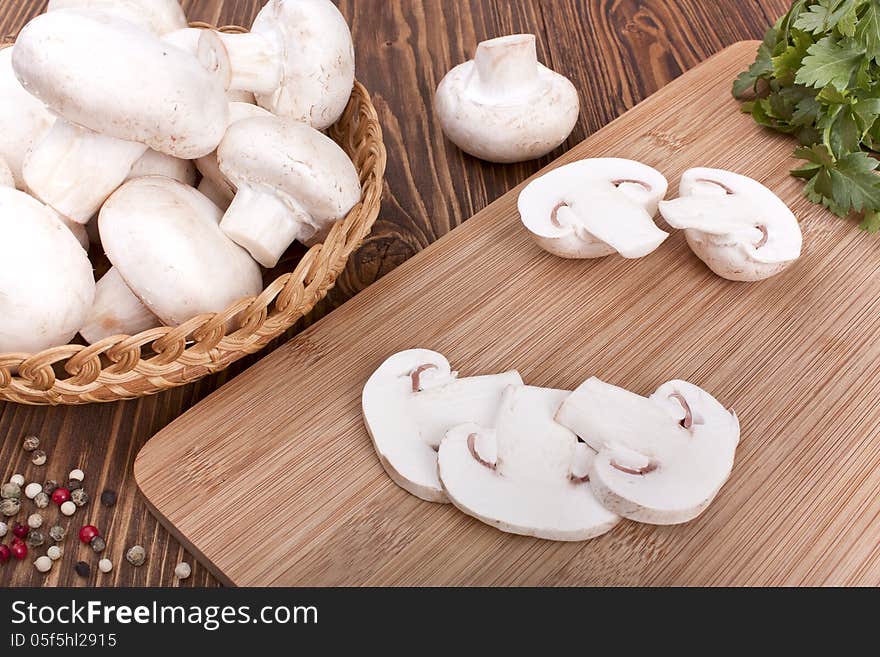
12;9;229;159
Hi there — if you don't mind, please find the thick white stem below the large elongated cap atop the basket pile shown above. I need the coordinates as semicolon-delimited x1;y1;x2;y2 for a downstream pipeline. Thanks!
23;119;147;224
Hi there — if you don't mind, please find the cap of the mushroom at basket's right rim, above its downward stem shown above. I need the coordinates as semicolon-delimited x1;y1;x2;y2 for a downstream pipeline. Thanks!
217;116;361;232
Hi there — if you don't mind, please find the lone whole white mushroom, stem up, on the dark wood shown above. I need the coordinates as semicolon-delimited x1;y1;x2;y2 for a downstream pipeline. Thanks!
434;34;580;162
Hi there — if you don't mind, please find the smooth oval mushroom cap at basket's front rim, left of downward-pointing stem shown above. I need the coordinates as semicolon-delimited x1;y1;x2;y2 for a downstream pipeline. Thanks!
98;176;262;326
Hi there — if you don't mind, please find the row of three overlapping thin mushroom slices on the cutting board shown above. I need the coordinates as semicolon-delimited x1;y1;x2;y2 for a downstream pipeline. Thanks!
361;349;740;541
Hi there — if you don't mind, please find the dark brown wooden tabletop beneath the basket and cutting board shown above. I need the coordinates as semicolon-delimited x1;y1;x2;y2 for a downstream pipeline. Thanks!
0;0;788;586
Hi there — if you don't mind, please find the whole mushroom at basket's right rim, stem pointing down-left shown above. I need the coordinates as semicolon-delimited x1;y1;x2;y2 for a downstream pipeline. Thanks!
217;117;361;268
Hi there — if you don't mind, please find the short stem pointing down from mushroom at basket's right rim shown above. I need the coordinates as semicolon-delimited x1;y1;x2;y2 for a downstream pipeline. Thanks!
220;185;315;269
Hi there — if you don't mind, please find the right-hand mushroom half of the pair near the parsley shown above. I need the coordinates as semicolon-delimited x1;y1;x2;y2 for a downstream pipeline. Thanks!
660;168;803;281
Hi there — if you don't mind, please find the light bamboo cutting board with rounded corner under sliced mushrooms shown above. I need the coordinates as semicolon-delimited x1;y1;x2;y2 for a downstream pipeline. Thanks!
135;42;880;586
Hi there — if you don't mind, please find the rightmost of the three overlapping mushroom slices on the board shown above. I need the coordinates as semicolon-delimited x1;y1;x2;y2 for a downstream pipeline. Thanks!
556;378;739;525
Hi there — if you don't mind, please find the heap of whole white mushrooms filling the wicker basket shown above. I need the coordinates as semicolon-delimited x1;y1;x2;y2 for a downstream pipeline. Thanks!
0;0;361;353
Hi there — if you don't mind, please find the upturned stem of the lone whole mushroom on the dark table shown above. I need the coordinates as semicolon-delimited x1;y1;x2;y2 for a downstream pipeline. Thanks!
474;34;538;99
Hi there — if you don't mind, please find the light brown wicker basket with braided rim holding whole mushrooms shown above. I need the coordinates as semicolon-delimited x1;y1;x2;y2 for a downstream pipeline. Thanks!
0;23;386;405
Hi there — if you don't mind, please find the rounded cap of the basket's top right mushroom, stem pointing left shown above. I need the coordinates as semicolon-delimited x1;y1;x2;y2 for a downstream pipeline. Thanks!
251;0;354;130
